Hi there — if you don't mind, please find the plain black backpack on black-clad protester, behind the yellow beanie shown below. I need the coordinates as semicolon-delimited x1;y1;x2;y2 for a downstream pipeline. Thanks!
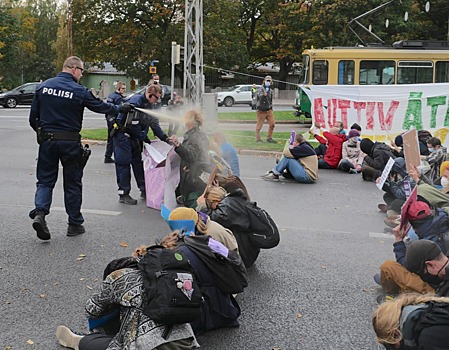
245;202;280;249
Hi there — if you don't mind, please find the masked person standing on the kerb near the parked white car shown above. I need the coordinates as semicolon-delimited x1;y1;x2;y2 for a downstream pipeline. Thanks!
256;75;276;143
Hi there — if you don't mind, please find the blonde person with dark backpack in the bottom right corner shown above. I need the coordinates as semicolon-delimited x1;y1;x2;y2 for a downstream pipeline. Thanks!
373;294;449;350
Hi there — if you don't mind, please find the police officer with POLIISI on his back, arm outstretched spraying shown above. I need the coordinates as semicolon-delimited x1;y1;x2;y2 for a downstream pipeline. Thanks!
29;56;134;240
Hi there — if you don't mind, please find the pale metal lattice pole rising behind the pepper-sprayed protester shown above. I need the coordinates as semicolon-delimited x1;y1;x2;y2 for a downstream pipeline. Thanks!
183;0;204;105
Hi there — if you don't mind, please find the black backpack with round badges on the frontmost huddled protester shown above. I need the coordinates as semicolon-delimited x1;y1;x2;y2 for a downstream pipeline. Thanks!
137;245;203;325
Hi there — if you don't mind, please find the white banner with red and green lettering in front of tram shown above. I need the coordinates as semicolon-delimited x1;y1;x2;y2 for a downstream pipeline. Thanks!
302;83;449;146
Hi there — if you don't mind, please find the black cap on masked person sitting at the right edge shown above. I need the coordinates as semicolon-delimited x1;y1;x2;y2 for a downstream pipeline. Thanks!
405;239;441;275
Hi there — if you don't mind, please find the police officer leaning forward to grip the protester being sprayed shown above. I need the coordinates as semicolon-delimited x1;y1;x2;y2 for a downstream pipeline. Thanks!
113;85;171;205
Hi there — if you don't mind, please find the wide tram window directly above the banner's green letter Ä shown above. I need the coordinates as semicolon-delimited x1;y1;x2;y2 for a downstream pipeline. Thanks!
398;61;433;84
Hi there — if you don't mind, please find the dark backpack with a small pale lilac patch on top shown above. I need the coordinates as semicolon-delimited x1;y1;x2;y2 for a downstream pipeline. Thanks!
184;235;248;294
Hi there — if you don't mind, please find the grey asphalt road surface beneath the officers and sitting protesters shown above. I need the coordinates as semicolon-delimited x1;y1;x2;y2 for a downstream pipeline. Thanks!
0;108;394;350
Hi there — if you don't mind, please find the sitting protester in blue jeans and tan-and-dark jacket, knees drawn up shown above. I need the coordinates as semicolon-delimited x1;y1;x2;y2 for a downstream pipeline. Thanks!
262;134;318;183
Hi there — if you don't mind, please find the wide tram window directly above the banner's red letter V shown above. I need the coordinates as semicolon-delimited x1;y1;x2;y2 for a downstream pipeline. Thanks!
359;61;394;85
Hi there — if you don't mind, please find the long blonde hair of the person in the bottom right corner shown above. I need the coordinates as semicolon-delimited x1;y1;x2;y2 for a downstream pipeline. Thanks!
373;293;449;344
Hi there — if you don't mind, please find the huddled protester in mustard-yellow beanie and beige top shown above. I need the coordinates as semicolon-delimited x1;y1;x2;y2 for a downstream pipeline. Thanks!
169;207;238;252
